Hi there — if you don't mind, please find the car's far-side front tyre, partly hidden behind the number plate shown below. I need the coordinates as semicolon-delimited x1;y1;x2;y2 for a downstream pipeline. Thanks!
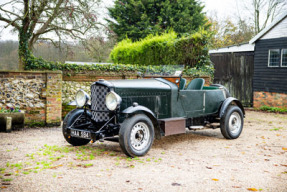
62;109;91;146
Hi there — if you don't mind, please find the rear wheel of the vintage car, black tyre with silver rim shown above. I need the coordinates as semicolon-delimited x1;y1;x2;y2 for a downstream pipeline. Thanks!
220;105;244;139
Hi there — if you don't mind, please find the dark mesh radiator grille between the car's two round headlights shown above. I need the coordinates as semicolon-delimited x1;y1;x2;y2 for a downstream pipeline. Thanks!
91;85;109;122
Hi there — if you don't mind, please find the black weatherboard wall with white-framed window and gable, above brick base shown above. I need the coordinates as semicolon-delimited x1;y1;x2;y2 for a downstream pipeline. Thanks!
249;12;287;94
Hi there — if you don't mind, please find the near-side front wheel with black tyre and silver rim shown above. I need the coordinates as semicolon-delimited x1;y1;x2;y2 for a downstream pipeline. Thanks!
119;114;154;157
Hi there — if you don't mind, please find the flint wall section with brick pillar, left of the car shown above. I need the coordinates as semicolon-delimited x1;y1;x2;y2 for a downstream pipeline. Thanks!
0;71;62;126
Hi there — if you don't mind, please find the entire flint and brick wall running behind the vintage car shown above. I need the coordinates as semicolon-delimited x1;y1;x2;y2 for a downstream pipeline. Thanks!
0;71;210;126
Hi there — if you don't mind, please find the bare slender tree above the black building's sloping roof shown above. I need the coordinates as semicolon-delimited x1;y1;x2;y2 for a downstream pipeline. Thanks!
237;0;287;33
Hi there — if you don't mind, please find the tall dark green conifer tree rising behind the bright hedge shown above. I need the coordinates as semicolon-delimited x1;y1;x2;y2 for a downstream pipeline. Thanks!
108;0;206;41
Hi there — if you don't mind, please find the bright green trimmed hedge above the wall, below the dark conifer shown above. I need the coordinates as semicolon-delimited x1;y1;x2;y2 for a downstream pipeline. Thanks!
110;29;210;68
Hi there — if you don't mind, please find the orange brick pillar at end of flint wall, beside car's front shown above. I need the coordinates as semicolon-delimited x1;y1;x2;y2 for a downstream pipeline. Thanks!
46;72;62;126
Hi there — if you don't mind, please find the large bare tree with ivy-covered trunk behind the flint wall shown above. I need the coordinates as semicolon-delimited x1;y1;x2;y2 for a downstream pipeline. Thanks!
0;0;101;69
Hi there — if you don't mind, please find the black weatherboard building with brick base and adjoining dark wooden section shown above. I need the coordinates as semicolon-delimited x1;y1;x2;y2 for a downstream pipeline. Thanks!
209;11;287;108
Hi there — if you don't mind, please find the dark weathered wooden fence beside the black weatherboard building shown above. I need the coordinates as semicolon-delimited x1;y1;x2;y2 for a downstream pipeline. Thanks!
210;52;254;106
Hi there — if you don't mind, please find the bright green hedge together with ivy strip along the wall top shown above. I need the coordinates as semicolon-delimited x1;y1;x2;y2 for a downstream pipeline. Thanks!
25;30;214;77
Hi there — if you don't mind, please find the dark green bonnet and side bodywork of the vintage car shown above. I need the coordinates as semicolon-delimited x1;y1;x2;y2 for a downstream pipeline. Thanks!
109;78;225;119
